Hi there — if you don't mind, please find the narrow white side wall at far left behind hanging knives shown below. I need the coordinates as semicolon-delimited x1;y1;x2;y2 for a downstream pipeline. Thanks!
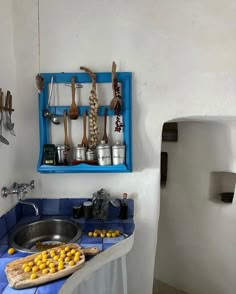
0;0;20;215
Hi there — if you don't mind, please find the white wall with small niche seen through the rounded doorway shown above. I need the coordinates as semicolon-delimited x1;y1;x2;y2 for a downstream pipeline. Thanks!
155;121;236;294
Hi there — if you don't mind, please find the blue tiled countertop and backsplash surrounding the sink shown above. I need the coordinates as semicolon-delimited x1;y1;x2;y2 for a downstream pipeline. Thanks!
0;198;135;294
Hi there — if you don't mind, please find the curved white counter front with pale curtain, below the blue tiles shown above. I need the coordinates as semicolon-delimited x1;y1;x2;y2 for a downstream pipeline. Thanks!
59;234;134;294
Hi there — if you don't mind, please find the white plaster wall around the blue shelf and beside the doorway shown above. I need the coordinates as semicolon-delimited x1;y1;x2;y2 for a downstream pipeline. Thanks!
1;0;236;294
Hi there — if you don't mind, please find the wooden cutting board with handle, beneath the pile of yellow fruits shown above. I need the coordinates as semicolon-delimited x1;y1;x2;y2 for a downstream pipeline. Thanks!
5;243;99;289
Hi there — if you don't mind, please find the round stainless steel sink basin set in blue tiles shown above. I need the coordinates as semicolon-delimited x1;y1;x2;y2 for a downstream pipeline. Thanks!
9;219;82;253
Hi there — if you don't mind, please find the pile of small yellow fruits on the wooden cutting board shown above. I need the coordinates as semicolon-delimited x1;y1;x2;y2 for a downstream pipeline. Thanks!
22;246;81;280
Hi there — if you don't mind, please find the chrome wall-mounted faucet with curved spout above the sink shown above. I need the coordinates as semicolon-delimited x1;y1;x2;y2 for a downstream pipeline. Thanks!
1;180;39;215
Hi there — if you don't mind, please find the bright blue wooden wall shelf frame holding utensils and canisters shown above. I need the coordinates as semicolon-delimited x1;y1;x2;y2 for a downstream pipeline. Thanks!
37;72;132;173
